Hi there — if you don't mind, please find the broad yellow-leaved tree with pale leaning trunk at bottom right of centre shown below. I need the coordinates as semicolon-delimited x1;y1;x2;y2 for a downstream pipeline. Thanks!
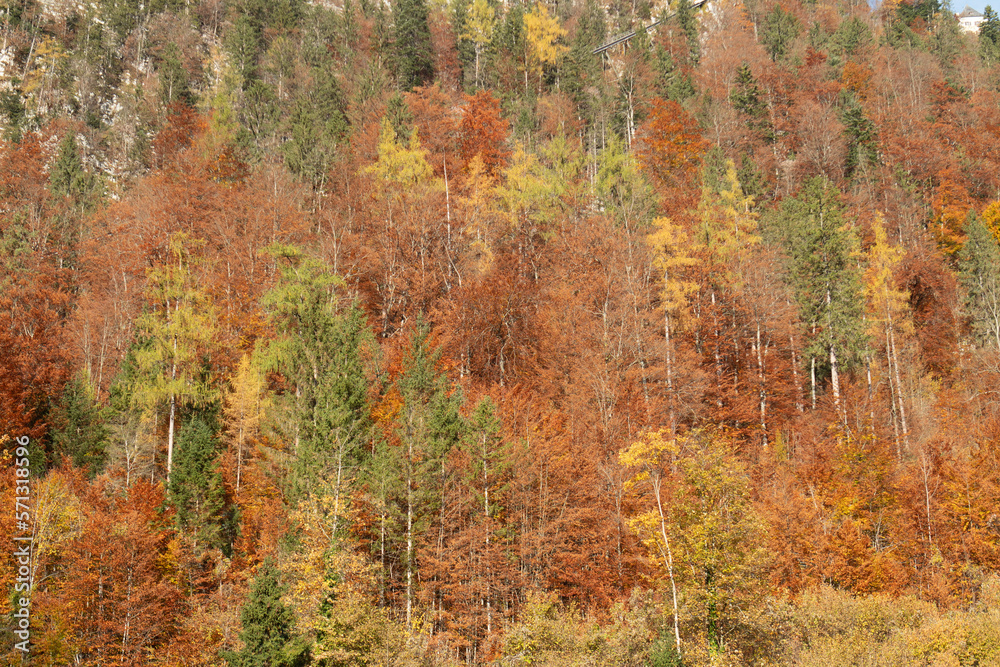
619;431;768;664
